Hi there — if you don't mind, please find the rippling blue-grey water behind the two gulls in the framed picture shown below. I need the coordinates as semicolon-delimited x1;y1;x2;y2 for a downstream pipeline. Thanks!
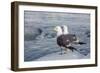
24;11;90;61
